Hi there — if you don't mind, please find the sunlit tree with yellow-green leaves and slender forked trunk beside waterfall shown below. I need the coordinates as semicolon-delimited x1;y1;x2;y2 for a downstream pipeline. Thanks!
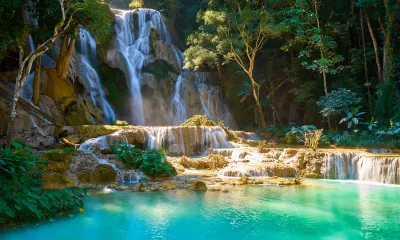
185;0;277;128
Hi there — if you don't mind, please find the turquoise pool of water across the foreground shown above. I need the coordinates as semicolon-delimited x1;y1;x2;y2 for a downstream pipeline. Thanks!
0;181;400;240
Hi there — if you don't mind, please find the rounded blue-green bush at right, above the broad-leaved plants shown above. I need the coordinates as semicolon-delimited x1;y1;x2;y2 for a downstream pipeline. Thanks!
317;88;361;117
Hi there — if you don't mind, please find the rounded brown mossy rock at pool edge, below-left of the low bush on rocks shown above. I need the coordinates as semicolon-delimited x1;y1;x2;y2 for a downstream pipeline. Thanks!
78;164;117;183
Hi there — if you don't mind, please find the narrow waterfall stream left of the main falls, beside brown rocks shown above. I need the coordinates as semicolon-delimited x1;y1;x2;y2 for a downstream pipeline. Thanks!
78;29;115;123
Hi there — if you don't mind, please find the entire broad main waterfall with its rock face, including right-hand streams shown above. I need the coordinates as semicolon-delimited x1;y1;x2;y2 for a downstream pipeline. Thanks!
106;9;234;127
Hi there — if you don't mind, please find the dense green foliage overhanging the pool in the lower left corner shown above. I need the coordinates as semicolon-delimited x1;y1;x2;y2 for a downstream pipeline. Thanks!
0;142;86;226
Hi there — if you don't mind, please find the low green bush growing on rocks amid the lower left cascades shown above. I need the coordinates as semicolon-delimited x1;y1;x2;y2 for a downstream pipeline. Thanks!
111;142;176;177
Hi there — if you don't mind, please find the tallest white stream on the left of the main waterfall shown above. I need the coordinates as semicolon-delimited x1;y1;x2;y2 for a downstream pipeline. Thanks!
107;9;171;125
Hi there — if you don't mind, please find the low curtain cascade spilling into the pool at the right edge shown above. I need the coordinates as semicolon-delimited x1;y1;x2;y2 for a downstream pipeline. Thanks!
324;153;400;184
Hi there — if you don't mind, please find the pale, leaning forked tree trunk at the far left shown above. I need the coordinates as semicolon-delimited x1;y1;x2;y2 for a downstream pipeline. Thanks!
7;0;86;146
